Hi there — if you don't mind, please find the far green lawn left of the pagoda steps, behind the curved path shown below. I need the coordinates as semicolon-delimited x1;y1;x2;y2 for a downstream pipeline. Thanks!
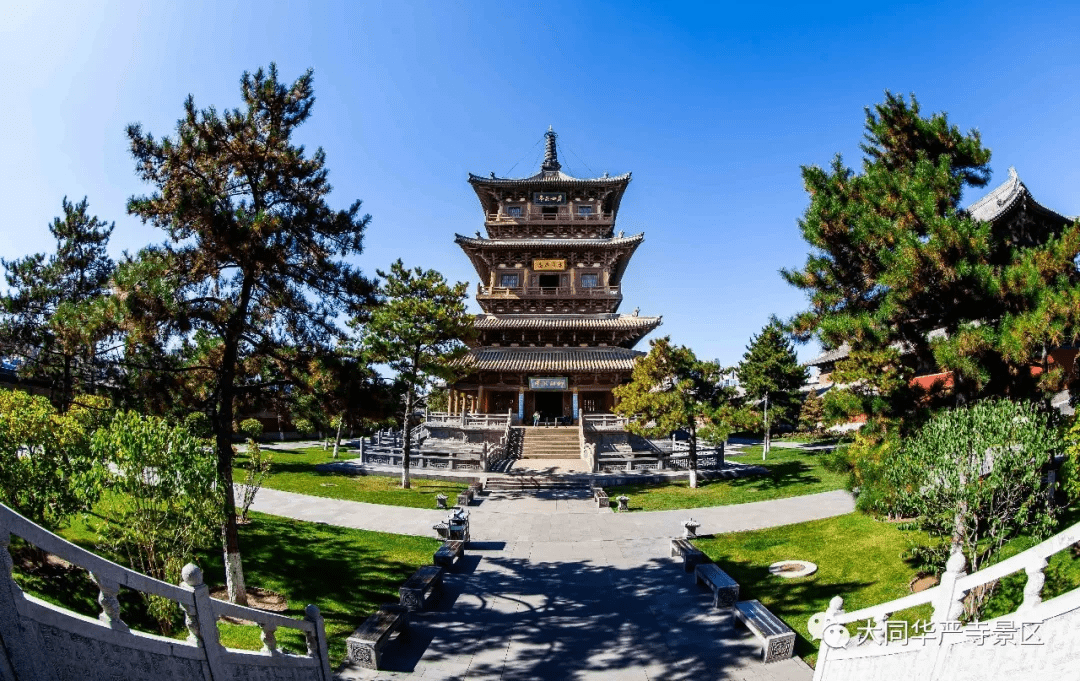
232;447;469;508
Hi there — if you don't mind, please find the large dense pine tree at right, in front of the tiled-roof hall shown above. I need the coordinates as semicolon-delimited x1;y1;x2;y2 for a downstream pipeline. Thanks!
783;93;1080;419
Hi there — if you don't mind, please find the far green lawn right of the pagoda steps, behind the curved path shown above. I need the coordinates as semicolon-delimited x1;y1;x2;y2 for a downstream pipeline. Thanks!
606;446;848;510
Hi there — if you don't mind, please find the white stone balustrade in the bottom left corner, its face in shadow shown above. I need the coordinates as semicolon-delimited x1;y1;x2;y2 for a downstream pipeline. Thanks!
0;504;332;681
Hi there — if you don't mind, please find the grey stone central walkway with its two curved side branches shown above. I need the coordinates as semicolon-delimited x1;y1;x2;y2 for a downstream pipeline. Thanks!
254;489;854;681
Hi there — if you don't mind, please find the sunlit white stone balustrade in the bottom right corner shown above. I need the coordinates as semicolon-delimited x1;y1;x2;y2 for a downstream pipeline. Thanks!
808;523;1080;681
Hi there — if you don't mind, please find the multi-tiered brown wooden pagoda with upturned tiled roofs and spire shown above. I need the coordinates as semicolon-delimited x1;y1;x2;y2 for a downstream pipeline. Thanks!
449;130;661;423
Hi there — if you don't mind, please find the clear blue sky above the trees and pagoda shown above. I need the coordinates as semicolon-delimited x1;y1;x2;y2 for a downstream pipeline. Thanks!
0;0;1080;364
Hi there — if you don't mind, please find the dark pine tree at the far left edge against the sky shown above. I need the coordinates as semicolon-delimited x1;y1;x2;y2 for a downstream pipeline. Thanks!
0;196;114;411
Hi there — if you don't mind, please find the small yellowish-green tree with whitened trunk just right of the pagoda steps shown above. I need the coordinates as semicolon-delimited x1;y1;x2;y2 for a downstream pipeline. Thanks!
613;336;735;488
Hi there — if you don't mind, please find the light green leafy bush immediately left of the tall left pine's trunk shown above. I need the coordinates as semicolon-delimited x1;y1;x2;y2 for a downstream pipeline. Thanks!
92;411;221;636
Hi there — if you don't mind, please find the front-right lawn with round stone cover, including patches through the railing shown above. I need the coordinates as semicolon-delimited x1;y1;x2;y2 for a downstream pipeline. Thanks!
694;508;1080;665
